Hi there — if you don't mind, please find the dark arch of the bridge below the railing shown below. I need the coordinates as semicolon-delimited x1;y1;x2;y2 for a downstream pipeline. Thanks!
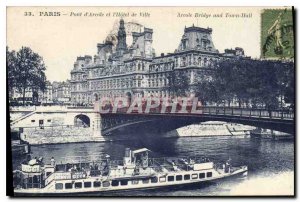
102;113;295;134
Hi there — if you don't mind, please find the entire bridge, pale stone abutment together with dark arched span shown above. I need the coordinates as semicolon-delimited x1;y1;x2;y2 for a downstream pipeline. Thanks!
10;107;295;144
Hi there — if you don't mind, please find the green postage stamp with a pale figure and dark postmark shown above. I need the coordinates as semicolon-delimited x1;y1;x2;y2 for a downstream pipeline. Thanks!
261;9;294;59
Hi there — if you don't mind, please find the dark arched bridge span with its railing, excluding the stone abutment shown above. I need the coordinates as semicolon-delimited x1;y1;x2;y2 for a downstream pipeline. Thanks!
101;107;295;134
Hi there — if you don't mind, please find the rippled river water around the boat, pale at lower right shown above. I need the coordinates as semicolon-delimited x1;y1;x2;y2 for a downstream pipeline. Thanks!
19;130;294;196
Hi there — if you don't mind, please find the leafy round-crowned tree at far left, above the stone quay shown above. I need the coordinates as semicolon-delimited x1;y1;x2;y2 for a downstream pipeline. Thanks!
7;47;46;105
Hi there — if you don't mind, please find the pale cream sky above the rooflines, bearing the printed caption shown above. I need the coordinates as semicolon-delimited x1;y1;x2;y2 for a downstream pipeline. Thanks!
7;7;274;81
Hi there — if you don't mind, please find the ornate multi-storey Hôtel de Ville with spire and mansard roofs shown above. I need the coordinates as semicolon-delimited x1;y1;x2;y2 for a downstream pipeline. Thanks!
71;19;244;105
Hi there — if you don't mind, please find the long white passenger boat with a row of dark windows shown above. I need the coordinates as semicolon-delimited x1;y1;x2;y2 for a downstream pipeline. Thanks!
14;148;248;195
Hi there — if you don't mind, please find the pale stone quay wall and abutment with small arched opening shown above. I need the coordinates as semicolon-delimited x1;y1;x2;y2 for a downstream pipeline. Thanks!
10;106;106;145
